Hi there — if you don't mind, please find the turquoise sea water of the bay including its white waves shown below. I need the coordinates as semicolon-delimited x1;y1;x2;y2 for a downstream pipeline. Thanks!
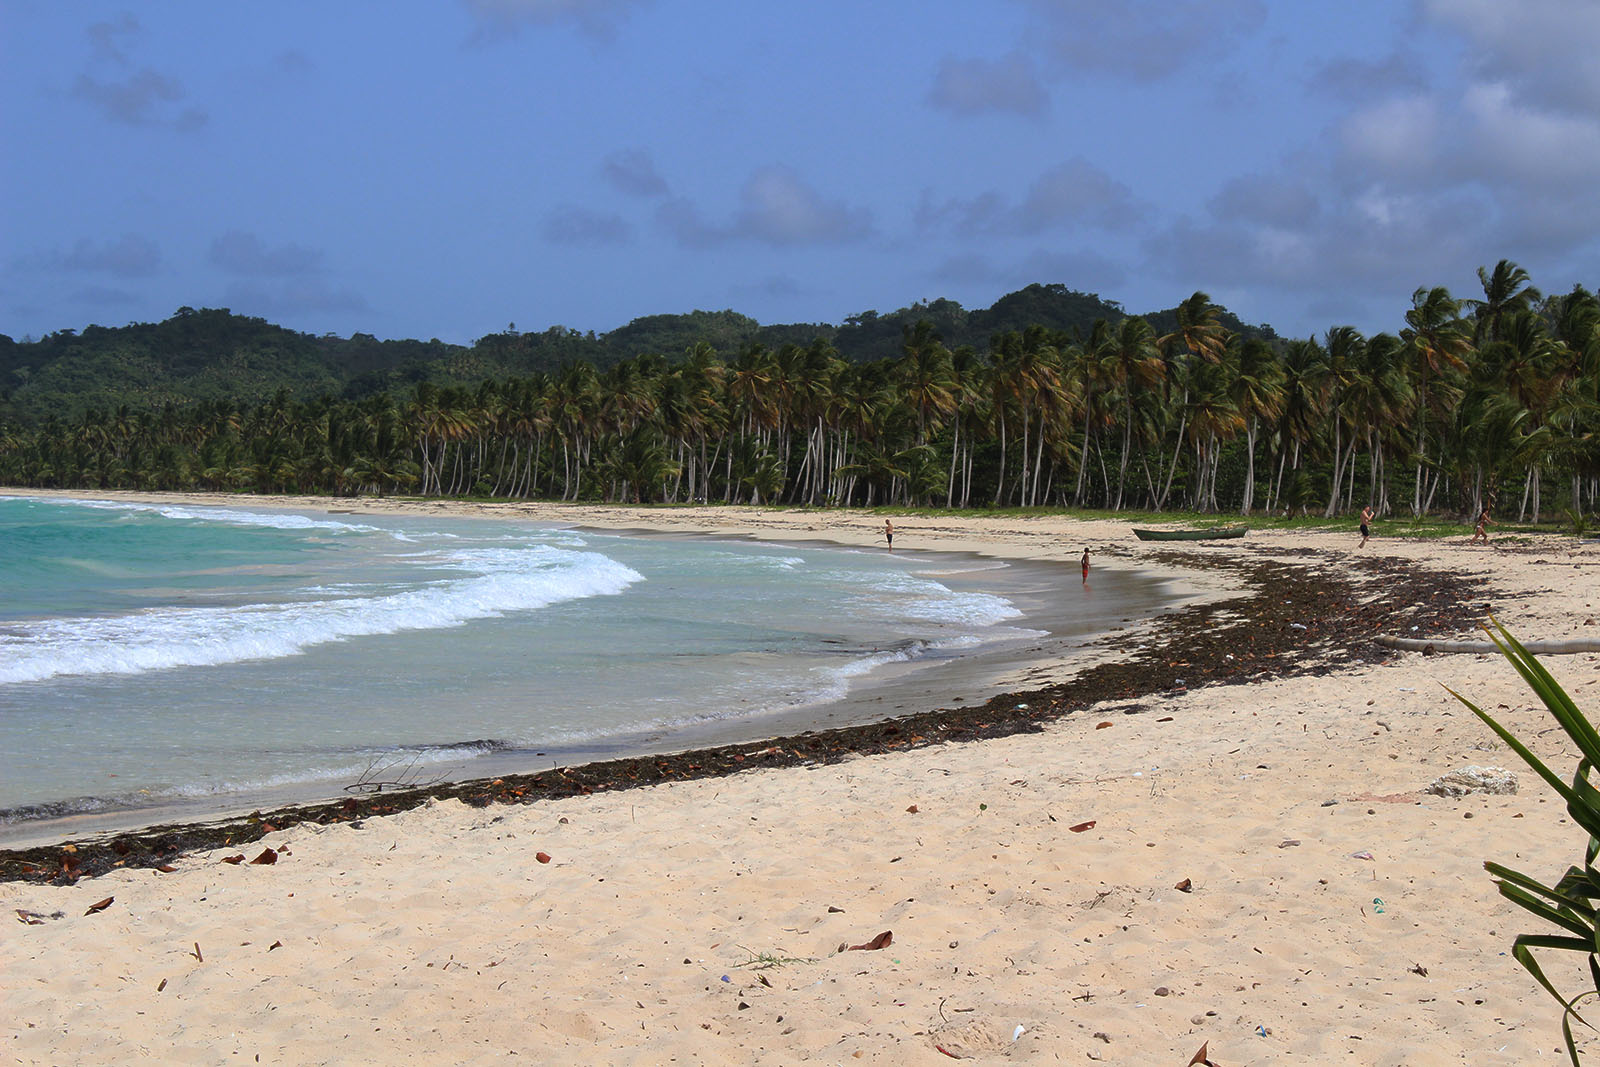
0;496;1126;827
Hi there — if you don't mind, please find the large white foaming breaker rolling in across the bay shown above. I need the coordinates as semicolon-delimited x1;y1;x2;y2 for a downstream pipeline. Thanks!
0;547;642;685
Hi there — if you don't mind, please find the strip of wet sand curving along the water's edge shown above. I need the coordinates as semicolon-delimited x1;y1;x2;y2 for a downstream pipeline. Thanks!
0;490;1237;851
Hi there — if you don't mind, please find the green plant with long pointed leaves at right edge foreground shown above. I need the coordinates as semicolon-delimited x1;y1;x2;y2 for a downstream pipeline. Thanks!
1450;622;1600;1067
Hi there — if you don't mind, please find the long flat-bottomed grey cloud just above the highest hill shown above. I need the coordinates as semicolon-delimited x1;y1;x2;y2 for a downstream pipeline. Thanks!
917;157;1146;237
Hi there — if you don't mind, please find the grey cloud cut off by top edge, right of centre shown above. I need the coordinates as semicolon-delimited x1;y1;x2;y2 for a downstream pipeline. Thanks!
1024;0;1267;82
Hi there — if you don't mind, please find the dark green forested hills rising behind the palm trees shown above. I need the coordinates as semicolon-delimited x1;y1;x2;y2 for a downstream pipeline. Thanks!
0;292;1274;424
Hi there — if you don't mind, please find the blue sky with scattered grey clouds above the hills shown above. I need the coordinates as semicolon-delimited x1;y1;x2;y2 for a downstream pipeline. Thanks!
0;0;1600;342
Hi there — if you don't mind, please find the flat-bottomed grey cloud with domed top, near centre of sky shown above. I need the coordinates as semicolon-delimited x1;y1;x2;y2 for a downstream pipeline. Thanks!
656;166;872;248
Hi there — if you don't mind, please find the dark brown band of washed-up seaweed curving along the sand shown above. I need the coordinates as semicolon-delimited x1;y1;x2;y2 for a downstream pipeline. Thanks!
0;545;1488;885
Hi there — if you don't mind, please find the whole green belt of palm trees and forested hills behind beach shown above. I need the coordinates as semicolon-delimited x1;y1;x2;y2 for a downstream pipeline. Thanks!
0;261;1600;530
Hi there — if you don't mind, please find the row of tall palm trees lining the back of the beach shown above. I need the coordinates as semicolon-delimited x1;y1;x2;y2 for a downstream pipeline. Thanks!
0;261;1600;520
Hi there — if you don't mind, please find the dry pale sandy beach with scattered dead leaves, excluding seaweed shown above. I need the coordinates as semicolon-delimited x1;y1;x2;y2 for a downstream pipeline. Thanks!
0;498;1600;1067
